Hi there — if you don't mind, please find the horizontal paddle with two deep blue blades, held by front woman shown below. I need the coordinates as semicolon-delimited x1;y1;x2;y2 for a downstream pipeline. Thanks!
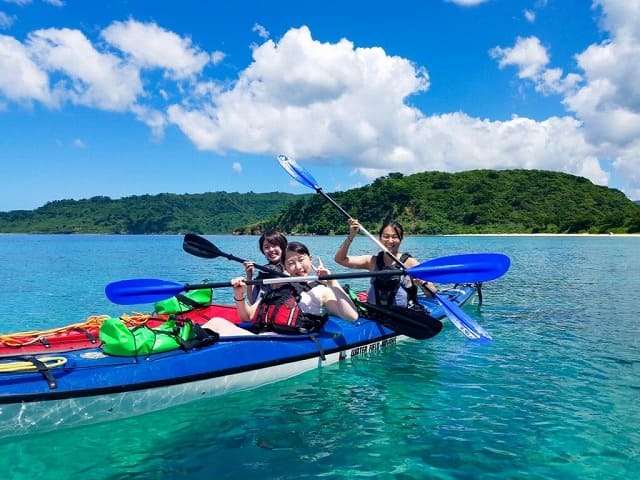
105;253;508;305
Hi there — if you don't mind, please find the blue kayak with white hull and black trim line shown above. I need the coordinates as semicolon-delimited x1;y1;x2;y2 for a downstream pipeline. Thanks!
0;285;476;437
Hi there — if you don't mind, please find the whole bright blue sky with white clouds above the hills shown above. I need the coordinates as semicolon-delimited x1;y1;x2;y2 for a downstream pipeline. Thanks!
0;0;640;211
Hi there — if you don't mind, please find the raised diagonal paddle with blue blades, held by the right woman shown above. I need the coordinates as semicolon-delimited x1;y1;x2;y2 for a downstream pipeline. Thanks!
277;155;510;340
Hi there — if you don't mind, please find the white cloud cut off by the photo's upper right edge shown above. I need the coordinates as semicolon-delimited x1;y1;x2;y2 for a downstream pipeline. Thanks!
490;0;640;199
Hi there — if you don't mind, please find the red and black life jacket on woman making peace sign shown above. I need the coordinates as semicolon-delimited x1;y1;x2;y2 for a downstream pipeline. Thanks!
253;282;328;334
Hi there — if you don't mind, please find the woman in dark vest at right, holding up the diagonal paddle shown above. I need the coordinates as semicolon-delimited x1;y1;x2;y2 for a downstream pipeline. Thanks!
334;218;435;307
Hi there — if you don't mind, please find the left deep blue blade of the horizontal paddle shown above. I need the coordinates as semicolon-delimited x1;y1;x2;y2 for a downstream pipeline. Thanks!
104;278;184;305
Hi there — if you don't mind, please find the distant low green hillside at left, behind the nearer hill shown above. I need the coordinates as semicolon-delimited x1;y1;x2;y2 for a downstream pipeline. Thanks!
0;192;300;234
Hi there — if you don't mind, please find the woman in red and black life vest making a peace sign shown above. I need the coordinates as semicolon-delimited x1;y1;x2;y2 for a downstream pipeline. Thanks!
203;242;358;336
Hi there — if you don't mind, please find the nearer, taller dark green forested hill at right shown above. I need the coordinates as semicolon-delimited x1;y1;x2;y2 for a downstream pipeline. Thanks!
276;170;640;235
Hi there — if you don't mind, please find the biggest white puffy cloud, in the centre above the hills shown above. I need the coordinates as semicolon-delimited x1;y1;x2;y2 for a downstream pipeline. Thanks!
169;27;608;193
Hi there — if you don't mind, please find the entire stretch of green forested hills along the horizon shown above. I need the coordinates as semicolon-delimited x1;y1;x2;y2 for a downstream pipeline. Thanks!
0;169;640;235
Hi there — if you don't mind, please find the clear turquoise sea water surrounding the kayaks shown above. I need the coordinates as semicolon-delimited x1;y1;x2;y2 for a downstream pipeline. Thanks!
0;235;640;480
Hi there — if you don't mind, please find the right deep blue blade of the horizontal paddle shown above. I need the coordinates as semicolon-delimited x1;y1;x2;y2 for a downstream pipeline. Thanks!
407;253;511;283
